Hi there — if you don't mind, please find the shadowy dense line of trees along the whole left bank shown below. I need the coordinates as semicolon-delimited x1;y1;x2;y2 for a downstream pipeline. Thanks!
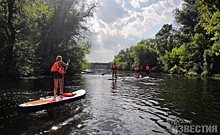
0;0;99;77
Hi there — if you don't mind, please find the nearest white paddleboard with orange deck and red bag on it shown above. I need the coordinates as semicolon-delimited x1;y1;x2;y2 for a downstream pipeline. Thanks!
18;89;86;110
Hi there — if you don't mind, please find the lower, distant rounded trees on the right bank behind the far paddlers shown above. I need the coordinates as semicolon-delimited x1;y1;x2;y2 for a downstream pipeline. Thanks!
113;39;157;70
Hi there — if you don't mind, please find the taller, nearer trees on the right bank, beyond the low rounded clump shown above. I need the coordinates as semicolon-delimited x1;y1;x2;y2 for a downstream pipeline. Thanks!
152;0;220;76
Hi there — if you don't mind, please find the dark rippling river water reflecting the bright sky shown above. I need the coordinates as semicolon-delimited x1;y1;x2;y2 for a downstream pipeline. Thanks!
0;72;220;135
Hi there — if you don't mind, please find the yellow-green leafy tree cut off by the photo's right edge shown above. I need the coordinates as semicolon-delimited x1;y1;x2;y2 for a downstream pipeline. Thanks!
197;0;220;75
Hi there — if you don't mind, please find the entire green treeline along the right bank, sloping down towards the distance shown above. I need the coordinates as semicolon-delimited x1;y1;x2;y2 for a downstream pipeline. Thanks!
114;0;220;76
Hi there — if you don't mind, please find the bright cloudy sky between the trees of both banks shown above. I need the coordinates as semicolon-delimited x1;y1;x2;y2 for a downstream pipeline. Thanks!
86;0;182;63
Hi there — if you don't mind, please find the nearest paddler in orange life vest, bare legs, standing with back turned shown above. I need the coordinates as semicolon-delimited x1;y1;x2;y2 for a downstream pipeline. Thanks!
51;55;70;101
